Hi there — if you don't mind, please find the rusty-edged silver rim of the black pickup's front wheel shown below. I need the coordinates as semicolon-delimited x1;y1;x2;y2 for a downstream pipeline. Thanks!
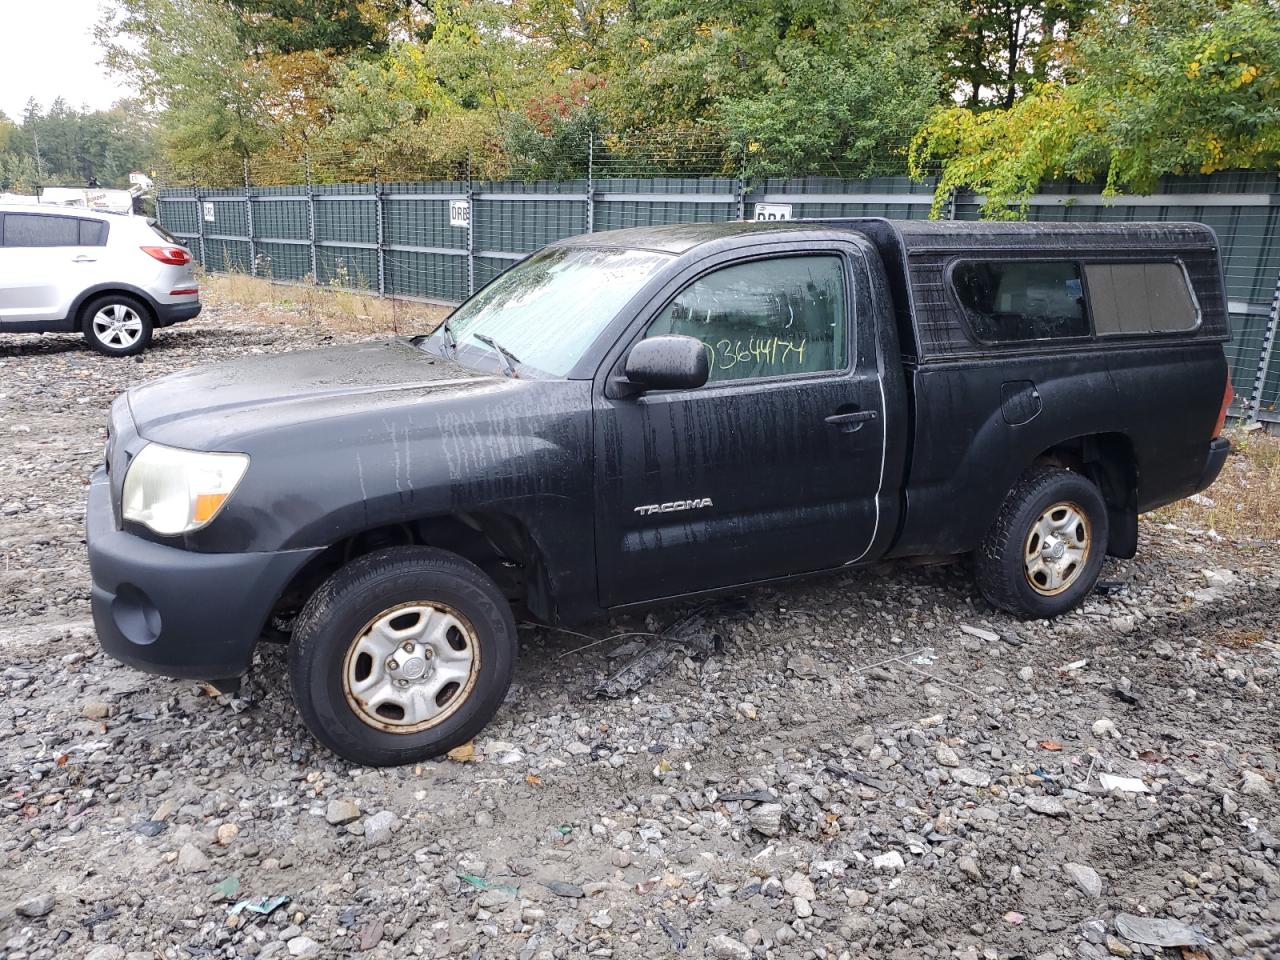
342;600;480;733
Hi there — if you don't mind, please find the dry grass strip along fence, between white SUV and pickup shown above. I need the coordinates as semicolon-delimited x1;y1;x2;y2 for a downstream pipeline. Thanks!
200;274;453;335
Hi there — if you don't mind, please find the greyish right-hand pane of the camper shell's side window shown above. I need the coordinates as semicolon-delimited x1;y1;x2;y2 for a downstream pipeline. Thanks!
1084;262;1199;337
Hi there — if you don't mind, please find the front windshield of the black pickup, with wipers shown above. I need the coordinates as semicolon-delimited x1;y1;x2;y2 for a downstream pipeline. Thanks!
438;247;671;376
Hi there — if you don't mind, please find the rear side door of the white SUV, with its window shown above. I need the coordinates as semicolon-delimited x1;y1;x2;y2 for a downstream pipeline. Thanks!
0;212;98;328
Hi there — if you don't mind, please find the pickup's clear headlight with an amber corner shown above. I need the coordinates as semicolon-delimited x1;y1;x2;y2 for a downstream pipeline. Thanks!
123;443;248;536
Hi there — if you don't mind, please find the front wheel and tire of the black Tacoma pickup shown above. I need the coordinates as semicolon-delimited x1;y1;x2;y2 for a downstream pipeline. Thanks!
289;547;516;767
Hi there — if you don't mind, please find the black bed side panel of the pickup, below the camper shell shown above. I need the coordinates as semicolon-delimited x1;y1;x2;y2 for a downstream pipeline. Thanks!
892;342;1226;556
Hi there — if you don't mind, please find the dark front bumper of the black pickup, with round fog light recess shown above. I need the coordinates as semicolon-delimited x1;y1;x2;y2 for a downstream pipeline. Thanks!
84;467;320;680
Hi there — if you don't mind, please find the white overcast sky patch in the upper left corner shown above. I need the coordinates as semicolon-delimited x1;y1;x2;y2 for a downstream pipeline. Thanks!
0;0;129;120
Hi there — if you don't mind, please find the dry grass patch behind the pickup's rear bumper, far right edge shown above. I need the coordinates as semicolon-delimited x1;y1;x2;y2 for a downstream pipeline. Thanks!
1151;428;1280;540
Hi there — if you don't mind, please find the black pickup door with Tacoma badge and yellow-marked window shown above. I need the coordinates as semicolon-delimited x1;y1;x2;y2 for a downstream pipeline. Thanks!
594;242;886;607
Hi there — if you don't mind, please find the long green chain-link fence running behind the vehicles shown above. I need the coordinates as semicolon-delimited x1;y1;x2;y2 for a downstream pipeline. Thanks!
156;145;1280;422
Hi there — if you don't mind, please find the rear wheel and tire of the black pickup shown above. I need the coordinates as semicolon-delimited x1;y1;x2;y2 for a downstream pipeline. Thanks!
975;466;1108;620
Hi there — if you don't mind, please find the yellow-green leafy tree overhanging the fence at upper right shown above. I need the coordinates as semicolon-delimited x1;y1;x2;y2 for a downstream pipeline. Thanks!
911;0;1280;216
